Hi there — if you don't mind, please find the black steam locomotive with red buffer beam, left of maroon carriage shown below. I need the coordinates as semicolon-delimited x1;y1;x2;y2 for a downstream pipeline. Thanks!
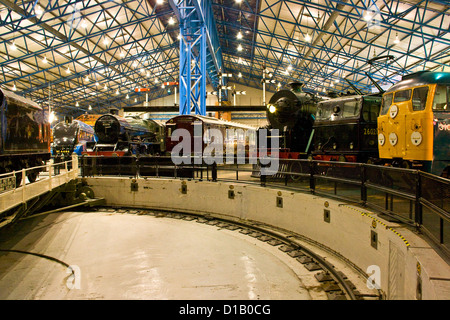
83;110;165;156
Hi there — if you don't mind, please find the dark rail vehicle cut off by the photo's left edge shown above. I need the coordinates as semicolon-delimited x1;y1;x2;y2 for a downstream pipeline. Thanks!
0;89;51;186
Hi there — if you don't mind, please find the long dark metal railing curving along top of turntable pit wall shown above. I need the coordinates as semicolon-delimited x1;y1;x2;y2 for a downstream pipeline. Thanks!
80;156;450;257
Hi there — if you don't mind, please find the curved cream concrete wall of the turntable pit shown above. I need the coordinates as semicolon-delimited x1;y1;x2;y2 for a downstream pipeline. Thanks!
87;177;450;300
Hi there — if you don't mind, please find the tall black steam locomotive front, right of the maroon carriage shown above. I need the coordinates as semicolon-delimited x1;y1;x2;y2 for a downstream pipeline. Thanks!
266;82;320;159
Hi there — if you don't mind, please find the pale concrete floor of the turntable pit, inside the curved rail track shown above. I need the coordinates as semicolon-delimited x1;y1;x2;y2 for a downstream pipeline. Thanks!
0;211;326;300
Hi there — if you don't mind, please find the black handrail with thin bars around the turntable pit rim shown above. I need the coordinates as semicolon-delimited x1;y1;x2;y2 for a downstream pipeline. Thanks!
80;156;450;258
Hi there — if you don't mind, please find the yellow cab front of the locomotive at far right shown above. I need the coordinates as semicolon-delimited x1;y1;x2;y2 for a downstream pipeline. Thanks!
378;72;447;172
